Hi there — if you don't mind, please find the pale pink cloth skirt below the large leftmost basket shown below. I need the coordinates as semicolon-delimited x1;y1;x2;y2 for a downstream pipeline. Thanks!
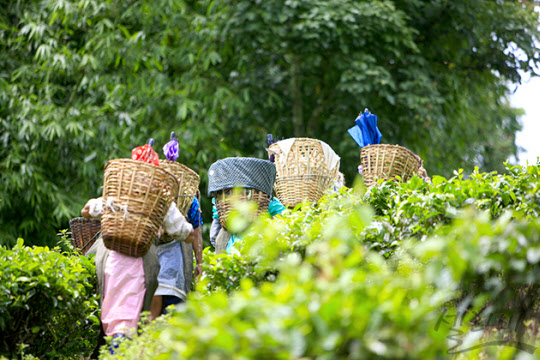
101;250;146;336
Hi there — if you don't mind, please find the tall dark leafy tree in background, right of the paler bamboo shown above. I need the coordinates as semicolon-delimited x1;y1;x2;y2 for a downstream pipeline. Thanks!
182;0;540;175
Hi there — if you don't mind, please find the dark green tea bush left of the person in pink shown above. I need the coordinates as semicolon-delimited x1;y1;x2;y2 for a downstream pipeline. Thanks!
0;239;99;359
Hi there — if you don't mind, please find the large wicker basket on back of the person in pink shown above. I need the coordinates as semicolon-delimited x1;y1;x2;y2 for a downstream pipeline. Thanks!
101;159;178;257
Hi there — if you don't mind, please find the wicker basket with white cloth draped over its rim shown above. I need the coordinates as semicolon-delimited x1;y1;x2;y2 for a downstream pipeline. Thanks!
268;138;340;207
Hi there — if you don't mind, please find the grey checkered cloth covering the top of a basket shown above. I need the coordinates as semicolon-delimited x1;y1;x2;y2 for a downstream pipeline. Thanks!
208;157;276;196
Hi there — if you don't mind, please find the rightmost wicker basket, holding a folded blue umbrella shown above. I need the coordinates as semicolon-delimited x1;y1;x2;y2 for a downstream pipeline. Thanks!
360;145;420;187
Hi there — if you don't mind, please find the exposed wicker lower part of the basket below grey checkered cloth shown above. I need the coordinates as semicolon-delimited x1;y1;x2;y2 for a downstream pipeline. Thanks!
215;188;271;230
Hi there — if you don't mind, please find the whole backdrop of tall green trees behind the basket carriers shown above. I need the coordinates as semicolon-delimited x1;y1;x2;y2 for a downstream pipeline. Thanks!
0;0;539;246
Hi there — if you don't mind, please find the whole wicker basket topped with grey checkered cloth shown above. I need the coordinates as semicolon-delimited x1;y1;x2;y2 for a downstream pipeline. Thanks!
208;157;276;230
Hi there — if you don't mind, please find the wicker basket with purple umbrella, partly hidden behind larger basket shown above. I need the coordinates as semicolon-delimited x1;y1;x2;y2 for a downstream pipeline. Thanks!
159;160;201;216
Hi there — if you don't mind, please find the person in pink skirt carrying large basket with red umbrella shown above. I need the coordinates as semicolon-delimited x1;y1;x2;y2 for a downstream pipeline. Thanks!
81;139;188;352
